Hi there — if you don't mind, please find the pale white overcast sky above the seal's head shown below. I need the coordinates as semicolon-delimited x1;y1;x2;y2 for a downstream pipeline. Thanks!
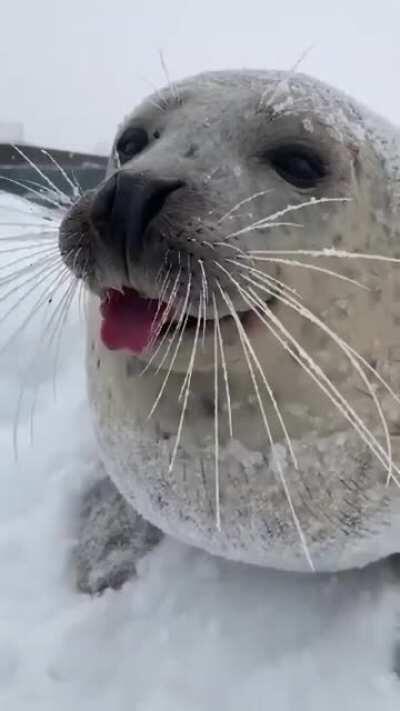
0;0;400;150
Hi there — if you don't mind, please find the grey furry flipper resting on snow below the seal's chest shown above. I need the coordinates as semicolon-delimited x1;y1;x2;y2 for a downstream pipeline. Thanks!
73;478;162;594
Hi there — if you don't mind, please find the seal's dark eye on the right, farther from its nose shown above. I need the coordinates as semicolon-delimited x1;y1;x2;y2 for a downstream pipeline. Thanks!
267;145;327;188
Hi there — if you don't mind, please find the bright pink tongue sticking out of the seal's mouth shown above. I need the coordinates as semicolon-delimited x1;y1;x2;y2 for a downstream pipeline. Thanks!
100;289;165;353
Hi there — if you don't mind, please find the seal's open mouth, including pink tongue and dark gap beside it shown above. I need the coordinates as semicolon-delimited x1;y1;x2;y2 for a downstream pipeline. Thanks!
100;288;248;354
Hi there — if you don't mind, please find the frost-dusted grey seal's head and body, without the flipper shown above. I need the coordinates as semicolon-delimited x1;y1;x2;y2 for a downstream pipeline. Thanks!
59;70;400;592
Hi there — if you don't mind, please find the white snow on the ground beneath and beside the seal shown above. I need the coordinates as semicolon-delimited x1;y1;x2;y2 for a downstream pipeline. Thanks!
0;191;400;711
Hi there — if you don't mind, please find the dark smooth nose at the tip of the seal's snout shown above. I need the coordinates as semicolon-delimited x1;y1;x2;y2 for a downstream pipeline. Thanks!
91;171;183;254
